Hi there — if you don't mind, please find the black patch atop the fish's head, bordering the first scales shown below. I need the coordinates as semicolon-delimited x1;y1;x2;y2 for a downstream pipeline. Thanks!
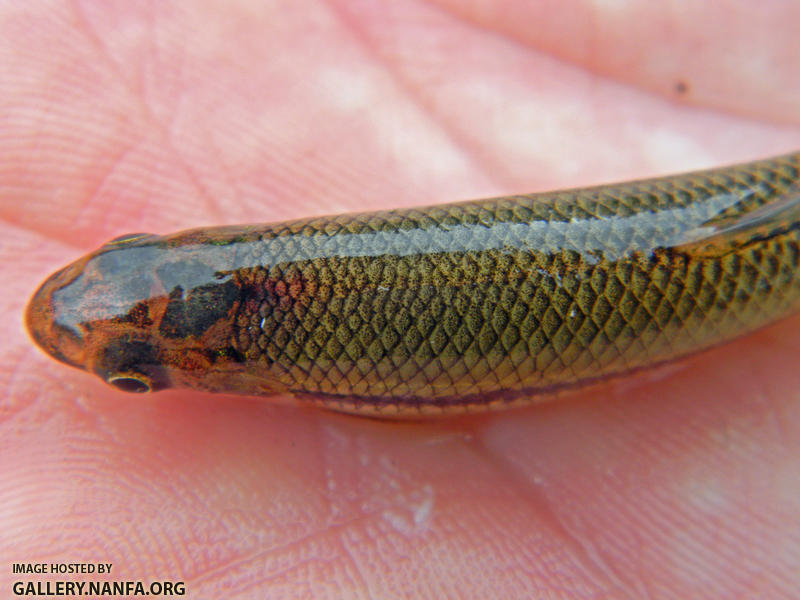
159;281;239;338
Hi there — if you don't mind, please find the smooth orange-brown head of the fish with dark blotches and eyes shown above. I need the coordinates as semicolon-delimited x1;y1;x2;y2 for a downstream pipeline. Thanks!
26;234;239;393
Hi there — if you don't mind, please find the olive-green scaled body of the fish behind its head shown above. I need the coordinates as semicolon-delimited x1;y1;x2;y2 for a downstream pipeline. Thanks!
223;154;800;405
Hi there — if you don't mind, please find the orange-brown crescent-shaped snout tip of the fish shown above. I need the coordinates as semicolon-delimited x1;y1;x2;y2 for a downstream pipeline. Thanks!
25;260;86;369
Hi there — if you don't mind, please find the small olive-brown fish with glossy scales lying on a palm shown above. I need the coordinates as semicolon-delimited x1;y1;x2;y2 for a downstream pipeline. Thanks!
25;152;800;417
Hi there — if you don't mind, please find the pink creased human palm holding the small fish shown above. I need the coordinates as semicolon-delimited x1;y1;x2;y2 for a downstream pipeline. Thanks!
0;0;800;599
